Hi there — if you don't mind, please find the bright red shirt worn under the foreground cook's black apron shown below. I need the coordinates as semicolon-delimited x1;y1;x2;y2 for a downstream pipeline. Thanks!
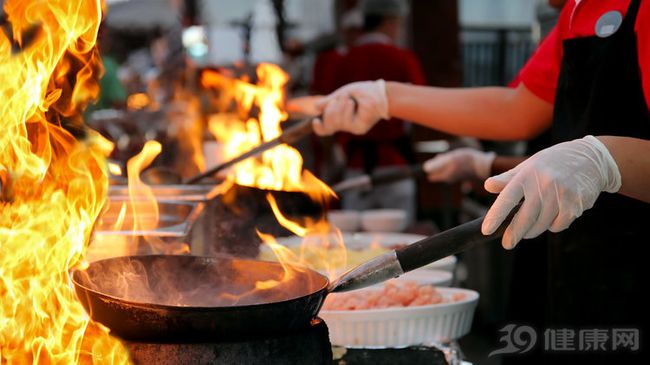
518;0;650;106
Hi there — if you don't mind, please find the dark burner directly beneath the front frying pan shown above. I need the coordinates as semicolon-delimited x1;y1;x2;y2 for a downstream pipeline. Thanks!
126;320;332;365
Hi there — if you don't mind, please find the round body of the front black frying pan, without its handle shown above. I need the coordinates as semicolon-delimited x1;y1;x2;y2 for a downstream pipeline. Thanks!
72;255;328;342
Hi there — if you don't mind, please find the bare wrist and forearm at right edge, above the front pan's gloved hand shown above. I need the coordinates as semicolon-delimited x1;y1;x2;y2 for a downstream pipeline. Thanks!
598;136;650;203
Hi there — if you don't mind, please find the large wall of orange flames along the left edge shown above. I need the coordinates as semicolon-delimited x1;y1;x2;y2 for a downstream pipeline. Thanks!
0;0;129;364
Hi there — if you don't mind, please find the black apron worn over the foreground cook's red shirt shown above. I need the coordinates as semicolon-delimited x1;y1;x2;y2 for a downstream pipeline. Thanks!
547;0;650;363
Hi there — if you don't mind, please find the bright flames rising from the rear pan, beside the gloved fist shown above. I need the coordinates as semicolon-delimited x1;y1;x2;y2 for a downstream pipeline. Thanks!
201;64;333;199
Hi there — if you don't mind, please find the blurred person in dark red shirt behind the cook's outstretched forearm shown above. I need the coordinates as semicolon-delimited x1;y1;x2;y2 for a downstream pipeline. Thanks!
334;0;425;222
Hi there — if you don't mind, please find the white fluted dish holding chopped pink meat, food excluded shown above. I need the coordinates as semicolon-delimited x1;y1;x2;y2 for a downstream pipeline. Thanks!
319;288;479;347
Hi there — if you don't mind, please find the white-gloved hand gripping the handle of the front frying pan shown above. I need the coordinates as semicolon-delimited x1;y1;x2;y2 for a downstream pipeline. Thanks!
482;136;621;249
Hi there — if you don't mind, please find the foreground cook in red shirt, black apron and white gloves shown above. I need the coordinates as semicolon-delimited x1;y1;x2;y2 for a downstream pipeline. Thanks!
314;0;650;362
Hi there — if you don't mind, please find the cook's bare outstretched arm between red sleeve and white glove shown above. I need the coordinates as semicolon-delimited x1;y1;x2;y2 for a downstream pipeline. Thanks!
386;82;553;140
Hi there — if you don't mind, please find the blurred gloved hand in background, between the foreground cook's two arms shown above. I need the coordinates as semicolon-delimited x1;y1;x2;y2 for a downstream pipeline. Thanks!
424;148;496;182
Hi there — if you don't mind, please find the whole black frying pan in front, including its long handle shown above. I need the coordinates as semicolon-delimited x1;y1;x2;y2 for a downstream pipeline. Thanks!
72;208;517;342
